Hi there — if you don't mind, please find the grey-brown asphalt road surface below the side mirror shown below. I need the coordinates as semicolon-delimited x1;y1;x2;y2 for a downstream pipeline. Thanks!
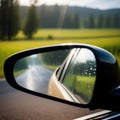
0;66;99;120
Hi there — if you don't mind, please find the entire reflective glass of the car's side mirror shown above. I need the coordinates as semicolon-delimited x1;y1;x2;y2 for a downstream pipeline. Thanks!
14;48;96;104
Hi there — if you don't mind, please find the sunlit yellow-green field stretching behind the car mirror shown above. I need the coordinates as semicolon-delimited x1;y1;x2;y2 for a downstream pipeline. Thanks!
0;29;120;77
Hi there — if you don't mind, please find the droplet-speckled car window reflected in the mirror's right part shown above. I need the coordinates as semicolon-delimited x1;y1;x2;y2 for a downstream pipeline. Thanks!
63;49;96;103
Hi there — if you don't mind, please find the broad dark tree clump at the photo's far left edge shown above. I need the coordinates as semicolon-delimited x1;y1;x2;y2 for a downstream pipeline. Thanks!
0;0;20;40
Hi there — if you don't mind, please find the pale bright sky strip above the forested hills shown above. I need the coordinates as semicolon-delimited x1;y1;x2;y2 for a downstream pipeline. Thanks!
19;0;120;9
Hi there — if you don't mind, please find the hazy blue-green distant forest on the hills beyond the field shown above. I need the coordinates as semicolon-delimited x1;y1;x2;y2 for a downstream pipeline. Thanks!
20;5;120;28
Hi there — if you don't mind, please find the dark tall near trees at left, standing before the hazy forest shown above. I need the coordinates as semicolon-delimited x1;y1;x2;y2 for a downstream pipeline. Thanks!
0;0;38;40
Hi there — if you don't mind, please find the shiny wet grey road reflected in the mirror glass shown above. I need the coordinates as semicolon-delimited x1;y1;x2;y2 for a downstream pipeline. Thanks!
16;65;53;94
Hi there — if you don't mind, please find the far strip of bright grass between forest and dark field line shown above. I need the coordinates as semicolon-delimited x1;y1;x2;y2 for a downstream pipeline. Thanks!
16;29;120;39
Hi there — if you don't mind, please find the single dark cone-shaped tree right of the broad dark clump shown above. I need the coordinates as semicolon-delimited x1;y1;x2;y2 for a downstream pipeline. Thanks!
23;4;39;39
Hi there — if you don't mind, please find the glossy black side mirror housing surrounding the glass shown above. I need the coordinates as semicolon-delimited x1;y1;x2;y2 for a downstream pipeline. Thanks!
4;44;120;111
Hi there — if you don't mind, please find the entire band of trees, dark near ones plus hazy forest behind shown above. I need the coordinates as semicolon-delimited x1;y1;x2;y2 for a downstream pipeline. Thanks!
0;0;120;40
